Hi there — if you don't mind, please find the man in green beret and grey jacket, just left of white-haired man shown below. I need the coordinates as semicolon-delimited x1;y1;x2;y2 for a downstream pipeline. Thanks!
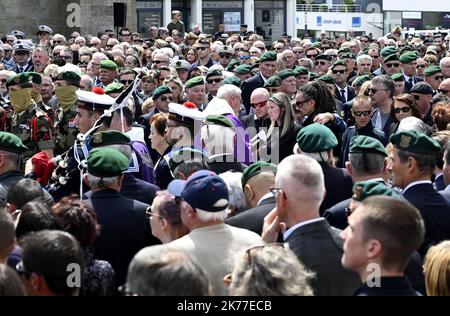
225;161;277;235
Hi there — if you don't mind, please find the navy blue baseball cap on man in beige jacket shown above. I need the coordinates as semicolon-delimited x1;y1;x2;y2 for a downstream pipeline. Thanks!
167;170;228;212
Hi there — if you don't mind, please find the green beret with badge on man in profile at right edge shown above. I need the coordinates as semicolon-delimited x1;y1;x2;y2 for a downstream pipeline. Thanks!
390;130;442;154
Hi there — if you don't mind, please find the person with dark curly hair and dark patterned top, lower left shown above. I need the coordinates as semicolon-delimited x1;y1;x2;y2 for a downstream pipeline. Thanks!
52;195;116;296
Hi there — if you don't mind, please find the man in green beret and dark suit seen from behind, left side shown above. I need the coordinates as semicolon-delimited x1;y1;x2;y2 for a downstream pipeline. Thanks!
84;148;159;284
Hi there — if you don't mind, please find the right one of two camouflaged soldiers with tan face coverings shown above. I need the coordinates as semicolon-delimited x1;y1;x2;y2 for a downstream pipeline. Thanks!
53;71;81;155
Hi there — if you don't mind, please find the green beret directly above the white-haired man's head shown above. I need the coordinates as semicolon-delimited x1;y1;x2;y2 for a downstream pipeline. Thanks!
297;123;338;153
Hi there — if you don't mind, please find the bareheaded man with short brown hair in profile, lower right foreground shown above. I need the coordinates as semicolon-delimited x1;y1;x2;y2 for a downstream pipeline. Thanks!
341;196;425;296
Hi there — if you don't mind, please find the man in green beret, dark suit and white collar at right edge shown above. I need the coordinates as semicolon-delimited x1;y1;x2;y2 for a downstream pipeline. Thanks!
388;130;450;255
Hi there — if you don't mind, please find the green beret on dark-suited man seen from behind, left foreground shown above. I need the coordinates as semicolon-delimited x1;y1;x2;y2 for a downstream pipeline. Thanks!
87;148;129;177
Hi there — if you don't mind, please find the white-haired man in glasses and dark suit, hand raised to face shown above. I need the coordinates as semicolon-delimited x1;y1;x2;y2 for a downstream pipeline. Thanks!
262;155;360;296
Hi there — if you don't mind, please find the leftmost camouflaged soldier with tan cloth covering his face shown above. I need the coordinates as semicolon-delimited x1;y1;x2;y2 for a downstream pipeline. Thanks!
6;73;55;169
